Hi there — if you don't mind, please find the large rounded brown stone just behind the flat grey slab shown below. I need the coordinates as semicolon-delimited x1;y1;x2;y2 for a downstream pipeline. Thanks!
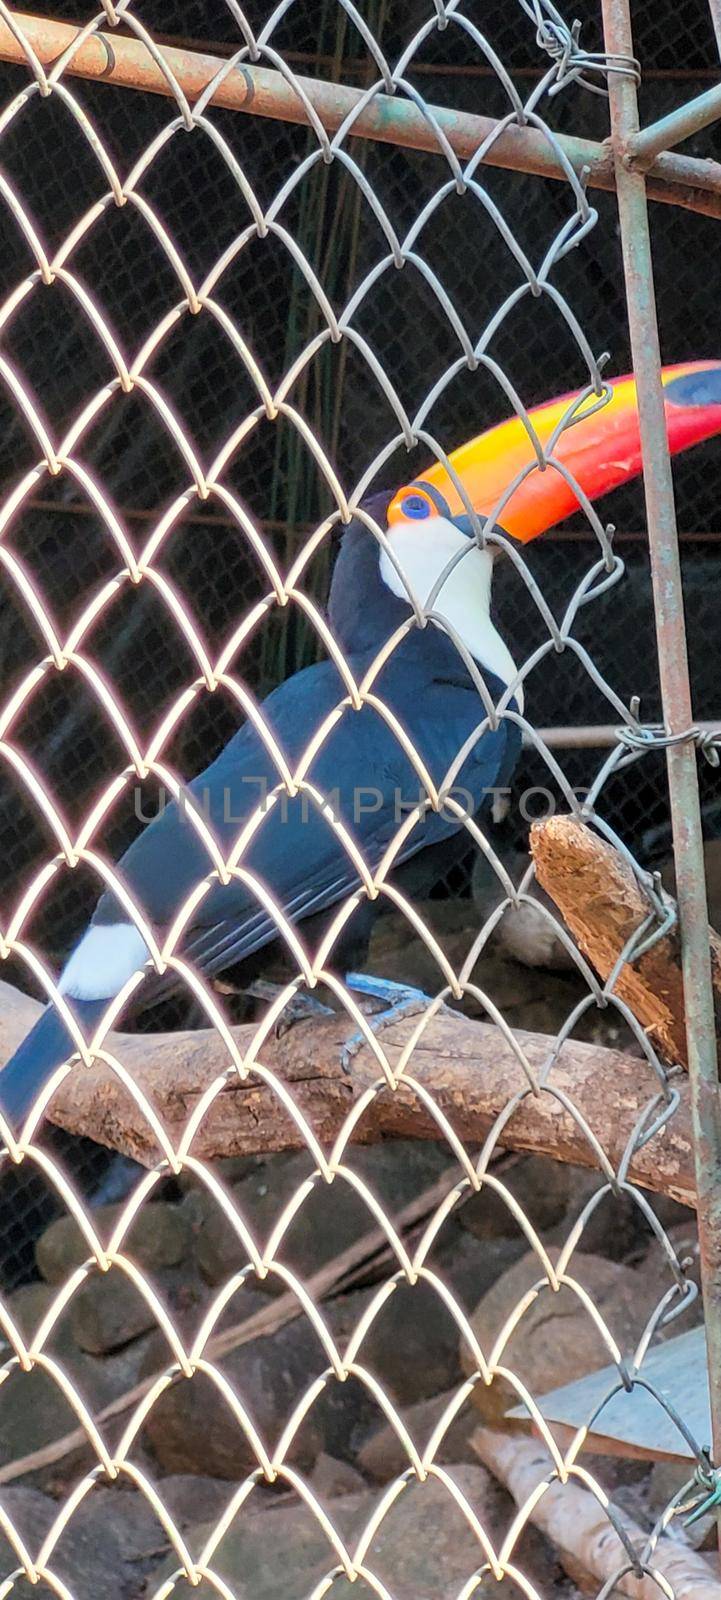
460;1248;659;1427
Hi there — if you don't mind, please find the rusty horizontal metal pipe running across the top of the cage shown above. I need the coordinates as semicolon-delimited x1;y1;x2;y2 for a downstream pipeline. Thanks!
0;11;721;218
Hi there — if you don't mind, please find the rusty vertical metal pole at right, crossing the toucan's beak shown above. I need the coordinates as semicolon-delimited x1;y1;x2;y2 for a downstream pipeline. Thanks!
603;0;721;1531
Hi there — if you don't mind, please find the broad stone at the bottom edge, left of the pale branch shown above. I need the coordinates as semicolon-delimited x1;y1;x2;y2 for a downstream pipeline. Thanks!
153;1464;561;1600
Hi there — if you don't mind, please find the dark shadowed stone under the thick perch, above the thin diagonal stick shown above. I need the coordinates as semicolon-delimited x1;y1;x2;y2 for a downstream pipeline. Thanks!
185;1139;452;1294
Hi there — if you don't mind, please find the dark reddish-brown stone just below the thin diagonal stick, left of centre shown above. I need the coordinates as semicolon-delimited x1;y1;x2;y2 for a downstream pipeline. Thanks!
142;1288;321;1478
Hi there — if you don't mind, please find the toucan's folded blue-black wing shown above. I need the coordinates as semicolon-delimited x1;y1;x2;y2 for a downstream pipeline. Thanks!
99;661;520;1000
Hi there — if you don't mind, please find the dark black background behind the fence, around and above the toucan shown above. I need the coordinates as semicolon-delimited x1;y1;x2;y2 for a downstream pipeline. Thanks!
0;0;721;982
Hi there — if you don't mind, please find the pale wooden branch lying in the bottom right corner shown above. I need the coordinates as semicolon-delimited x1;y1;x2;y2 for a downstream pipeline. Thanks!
472;1427;721;1600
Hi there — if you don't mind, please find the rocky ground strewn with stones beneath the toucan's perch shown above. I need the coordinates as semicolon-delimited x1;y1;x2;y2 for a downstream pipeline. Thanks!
0;1142;706;1600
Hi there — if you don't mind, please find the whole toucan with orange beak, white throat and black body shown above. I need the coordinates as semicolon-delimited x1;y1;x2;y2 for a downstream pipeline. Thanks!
0;362;721;1136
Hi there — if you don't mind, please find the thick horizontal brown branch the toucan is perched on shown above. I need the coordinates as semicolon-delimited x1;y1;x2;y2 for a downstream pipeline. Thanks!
0;984;695;1206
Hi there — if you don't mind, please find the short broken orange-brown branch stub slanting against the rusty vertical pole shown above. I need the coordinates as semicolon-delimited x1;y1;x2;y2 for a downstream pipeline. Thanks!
531;816;721;1067
